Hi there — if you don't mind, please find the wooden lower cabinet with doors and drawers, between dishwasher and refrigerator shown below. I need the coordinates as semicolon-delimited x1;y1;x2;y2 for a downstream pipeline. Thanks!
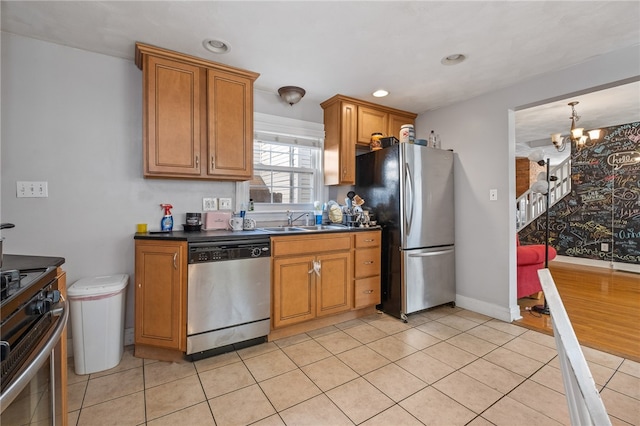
271;230;380;329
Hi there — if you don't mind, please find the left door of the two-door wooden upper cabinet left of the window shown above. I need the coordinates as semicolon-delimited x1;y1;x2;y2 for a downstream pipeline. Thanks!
144;56;203;176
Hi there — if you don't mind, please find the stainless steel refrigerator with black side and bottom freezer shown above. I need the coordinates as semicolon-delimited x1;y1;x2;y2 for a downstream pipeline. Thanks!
355;143;456;321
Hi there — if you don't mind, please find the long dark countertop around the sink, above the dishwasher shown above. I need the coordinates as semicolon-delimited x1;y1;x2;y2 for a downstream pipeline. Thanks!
133;225;382;242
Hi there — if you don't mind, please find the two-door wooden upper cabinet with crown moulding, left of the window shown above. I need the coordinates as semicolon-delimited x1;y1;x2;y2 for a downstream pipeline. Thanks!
136;43;259;181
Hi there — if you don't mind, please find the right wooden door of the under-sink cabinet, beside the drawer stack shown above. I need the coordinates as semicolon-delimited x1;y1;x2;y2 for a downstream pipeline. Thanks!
314;252;352;316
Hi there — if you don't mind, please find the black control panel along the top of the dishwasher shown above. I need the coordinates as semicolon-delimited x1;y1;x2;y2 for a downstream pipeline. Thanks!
189;239;271;264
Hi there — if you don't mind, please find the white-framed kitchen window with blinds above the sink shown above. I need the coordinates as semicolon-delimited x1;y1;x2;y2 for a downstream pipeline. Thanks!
241;112;326;211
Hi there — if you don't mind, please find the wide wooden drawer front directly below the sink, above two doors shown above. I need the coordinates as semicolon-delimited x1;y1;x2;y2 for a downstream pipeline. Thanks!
271;233;351;257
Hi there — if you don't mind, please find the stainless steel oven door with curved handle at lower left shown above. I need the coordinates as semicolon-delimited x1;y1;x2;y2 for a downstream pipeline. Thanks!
0;300;69;425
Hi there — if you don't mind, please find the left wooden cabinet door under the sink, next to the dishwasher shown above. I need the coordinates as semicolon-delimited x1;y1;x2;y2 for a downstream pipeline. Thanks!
273;256;316;328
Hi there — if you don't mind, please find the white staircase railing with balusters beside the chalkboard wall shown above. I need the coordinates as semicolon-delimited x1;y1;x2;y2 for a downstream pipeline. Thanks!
516;157;571;232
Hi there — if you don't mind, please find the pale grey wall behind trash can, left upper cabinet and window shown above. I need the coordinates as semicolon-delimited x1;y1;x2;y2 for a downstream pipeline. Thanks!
0;33;322;327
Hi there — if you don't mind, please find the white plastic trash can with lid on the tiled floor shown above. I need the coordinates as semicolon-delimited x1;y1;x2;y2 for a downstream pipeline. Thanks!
67;274;129;375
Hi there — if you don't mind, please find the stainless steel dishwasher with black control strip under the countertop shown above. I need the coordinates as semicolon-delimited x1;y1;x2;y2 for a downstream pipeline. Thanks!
187;236;271;359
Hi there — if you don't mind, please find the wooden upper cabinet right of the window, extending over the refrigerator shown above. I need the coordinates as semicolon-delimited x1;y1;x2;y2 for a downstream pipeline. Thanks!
320;95;417;185
